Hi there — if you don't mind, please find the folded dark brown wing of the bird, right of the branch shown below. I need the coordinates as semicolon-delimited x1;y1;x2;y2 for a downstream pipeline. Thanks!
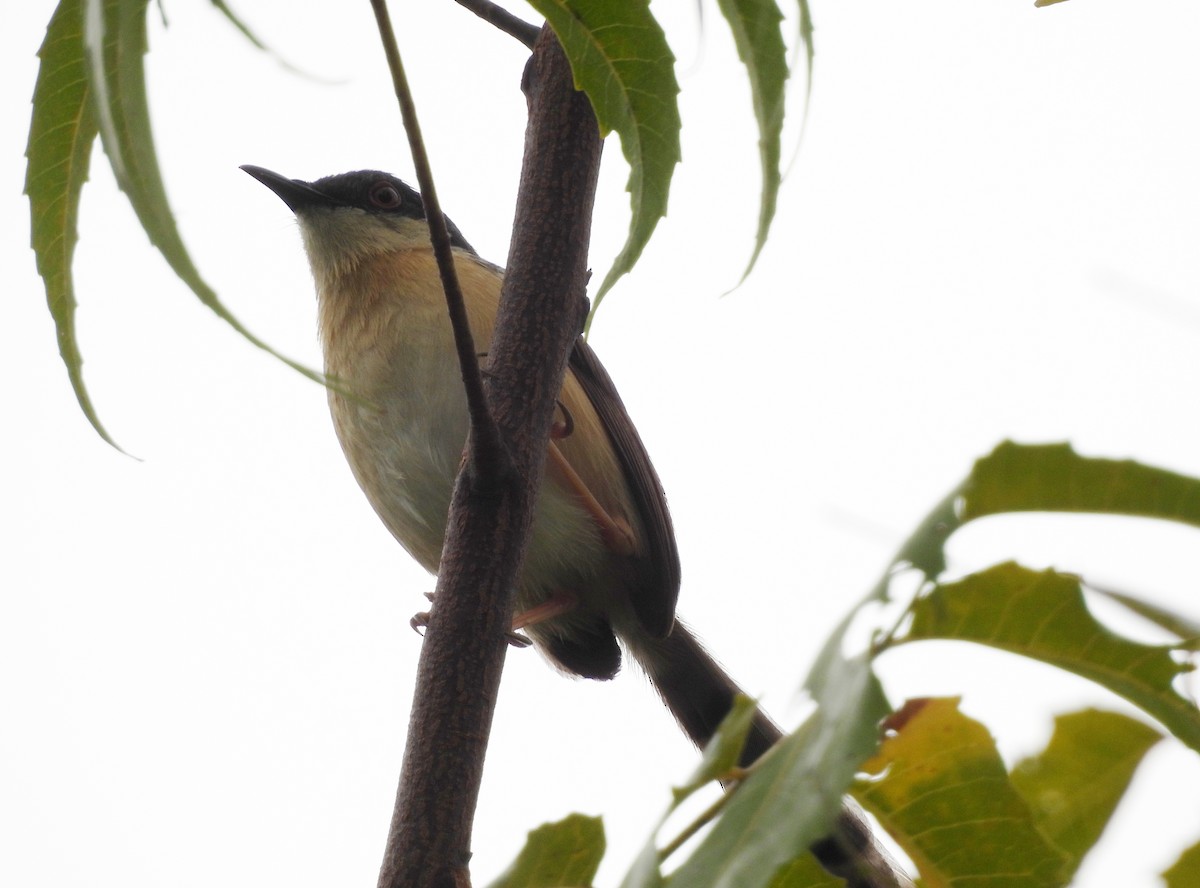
568;338;679;637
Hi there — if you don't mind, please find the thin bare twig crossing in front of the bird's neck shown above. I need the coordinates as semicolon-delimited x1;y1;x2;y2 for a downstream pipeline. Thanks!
371;0;503;476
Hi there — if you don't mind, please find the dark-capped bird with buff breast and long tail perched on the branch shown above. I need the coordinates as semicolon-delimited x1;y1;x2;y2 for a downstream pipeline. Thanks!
241;166;897;884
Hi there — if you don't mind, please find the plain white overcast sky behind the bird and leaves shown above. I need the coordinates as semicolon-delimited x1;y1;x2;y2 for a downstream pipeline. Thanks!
0;0;1200;888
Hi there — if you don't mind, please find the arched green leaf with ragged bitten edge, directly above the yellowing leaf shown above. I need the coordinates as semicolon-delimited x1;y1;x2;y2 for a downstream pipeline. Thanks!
898;563;1200;750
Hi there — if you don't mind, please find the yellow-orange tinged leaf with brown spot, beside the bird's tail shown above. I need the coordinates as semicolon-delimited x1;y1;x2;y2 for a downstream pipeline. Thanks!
851;700;1066;888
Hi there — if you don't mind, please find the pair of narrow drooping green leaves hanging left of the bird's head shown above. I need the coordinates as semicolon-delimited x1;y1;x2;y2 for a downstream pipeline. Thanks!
25;0;322;446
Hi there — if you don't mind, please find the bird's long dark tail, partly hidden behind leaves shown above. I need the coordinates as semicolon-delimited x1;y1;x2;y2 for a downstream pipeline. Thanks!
631;622;907;888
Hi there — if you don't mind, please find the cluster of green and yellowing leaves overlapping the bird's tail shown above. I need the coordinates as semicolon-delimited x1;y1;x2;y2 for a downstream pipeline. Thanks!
493;443;1200;888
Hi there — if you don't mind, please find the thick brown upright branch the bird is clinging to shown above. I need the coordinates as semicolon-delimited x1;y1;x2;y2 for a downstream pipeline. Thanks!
379;24;600;888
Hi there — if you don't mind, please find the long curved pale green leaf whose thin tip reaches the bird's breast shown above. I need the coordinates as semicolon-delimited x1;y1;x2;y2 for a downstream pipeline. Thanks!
83;0;324;383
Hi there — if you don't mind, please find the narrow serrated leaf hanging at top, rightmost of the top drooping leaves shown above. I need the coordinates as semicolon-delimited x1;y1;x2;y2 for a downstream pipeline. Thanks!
718;0;792;281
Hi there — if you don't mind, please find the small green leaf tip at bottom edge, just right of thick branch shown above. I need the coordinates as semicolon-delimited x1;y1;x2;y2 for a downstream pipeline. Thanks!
491;814;605;888
